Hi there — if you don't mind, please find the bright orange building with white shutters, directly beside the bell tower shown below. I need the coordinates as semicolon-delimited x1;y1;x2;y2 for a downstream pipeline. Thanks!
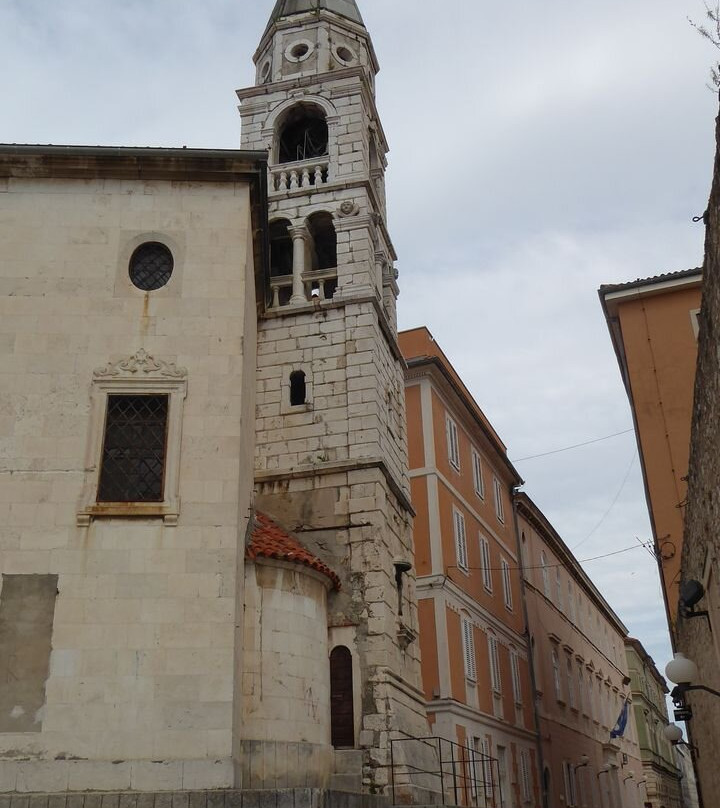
399;328;541;808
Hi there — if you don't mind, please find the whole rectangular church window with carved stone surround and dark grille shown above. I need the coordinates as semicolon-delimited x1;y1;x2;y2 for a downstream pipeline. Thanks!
77;348;188;525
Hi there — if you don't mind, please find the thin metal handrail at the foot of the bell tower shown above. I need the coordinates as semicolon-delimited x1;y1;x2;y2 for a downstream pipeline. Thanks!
390;736;504;808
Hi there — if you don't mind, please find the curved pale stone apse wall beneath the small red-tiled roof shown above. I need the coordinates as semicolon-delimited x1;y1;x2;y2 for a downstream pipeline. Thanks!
240;559;332;788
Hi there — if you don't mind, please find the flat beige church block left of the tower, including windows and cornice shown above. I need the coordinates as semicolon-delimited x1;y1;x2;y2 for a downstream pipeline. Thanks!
0;147;266;792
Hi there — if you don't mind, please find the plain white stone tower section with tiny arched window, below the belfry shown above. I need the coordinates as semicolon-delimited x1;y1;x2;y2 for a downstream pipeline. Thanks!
255;303;409;492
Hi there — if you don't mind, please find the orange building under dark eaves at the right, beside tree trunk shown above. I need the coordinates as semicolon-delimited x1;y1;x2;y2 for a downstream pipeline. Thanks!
599;269;702;631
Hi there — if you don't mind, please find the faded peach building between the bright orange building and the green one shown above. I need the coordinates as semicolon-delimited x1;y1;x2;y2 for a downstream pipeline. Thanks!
515;493;644;808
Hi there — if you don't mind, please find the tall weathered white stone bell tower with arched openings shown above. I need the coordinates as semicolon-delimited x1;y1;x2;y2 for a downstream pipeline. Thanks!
238;0;429;793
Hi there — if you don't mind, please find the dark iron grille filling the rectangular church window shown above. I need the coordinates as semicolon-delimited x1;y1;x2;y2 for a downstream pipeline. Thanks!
98;395;168;502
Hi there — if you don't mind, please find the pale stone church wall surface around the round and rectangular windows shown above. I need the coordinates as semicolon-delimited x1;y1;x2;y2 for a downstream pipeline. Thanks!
0;179;256;792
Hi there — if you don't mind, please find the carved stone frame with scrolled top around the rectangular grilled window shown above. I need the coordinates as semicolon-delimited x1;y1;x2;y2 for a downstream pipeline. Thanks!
77;348;187;525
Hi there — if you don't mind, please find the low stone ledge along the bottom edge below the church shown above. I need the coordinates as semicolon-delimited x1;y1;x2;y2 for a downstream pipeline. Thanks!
0;788;390;808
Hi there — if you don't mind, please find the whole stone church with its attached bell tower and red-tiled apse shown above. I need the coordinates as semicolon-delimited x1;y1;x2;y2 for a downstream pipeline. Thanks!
0;0;433;805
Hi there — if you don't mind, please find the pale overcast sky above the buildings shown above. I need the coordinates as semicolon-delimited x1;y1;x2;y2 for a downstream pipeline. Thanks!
0;0;717;669
